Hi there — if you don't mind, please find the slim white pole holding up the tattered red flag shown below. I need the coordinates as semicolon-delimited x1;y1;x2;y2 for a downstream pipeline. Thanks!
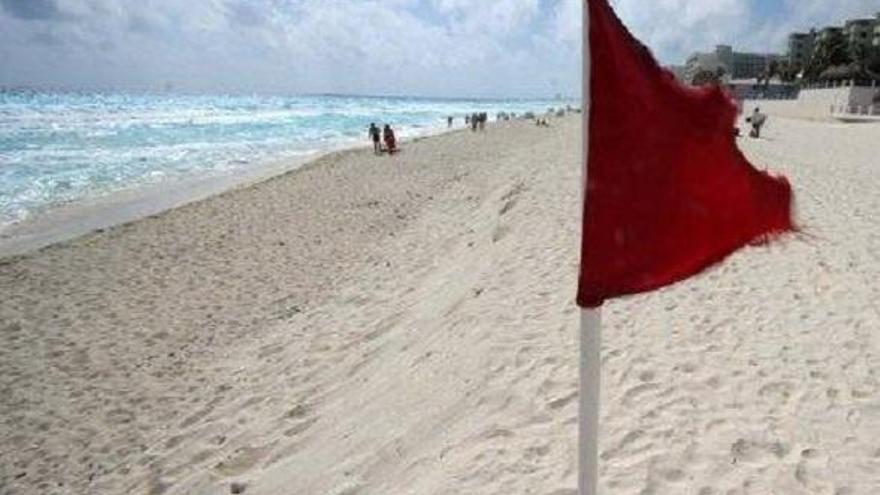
578;0;602;495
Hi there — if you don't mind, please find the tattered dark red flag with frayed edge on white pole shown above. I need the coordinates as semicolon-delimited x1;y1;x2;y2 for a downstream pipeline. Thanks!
578;0;794;307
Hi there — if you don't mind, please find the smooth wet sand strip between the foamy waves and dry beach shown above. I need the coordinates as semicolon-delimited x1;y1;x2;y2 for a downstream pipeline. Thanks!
0;122;468;260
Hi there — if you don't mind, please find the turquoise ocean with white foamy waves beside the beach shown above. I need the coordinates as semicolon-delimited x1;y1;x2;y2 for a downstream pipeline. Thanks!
0;91;571;232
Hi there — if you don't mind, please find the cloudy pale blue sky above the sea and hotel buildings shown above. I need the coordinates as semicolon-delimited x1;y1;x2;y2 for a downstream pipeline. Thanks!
0;0;880;97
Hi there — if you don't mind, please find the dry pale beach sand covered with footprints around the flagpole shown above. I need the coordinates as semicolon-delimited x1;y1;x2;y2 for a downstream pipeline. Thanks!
0;117;880;495
